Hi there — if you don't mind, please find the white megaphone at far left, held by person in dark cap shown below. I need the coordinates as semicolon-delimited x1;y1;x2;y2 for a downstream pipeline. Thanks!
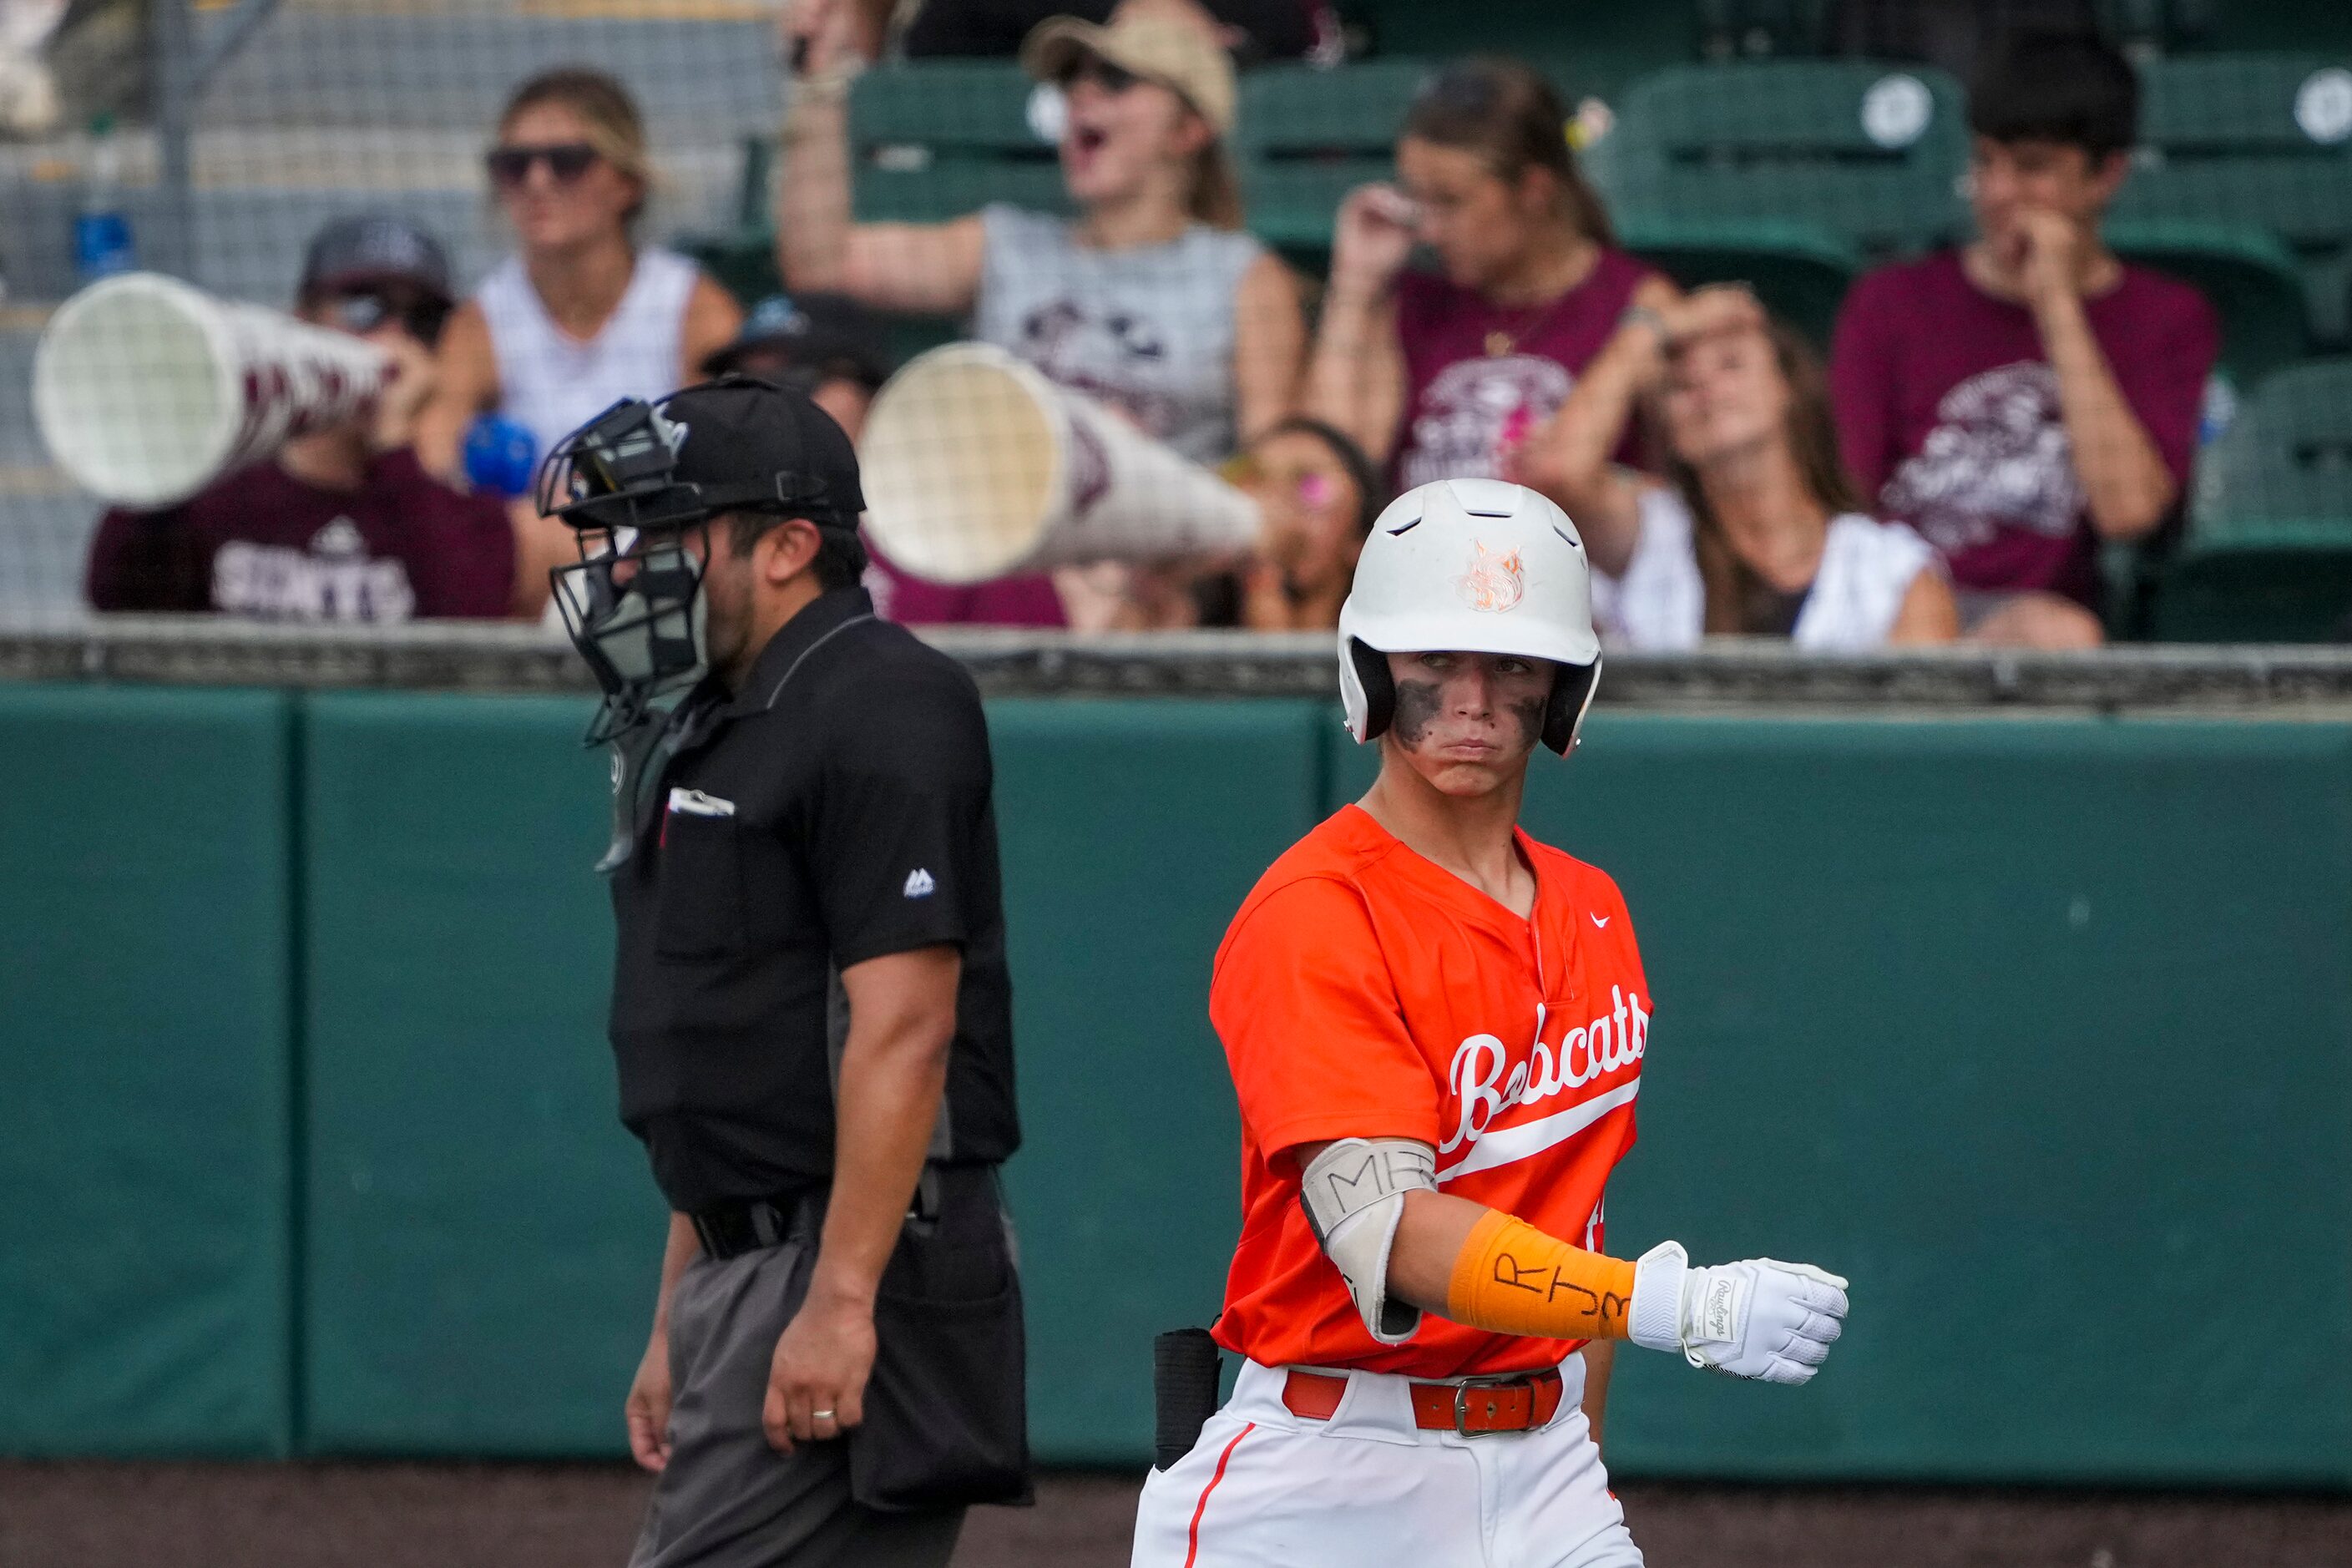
33;273;392;508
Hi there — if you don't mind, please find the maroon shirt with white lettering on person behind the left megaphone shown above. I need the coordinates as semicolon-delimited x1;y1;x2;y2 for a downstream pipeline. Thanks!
84;449;515;620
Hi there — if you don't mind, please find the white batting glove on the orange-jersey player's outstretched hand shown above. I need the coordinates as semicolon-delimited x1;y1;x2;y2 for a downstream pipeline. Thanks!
1627;1242;1846;1383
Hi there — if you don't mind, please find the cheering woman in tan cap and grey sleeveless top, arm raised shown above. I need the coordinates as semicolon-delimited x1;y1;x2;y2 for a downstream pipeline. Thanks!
776;0;1305;463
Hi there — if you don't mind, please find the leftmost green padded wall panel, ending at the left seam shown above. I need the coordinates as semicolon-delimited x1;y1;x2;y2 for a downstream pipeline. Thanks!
0;684;294;1455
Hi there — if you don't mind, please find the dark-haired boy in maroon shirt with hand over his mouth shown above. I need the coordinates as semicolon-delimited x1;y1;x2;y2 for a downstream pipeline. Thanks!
1830;35;2218;649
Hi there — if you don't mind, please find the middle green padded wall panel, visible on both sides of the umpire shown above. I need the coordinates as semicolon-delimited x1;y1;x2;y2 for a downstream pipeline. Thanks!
284;694;1327;1459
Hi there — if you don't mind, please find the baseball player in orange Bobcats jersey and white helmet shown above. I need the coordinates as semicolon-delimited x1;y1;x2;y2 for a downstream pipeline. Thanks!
1134;479;1846;1568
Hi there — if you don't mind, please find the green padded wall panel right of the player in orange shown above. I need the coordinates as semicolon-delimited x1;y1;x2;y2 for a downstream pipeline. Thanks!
1338;712;2352;1485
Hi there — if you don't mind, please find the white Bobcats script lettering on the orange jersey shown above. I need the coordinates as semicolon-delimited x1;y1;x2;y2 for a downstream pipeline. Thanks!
1437;985;1649;1182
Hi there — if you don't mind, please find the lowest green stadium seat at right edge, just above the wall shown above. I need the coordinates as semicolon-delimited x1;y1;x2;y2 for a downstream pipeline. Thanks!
2152;360;2352;642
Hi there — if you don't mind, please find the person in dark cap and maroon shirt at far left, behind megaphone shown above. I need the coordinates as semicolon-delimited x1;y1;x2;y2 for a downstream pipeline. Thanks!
84;219;515;620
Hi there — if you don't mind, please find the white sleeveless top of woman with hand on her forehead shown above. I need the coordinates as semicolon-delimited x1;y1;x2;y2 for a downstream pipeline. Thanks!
1592;487;1935;654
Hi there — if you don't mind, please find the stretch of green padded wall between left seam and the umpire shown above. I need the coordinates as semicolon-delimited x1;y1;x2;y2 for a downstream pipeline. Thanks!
303;694;668;1455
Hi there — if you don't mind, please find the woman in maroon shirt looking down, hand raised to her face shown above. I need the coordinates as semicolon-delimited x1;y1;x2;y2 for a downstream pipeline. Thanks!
1305;58;1675;491
